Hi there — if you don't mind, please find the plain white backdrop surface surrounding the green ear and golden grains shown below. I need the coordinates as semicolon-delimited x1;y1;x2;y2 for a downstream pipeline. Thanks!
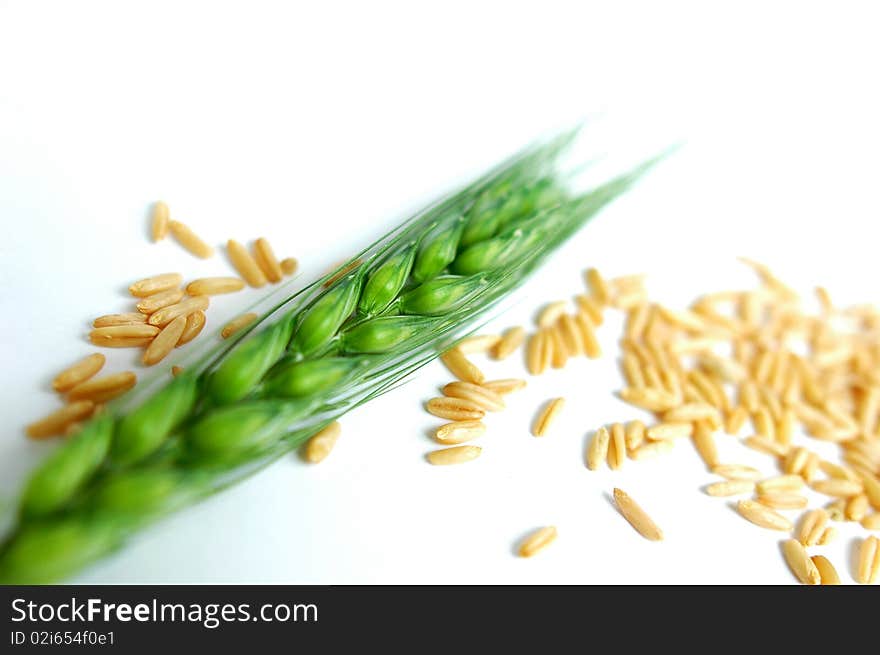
0;1;880;584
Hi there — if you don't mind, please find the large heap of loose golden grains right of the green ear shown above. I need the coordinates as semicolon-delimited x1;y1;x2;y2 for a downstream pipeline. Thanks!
427;260;880;584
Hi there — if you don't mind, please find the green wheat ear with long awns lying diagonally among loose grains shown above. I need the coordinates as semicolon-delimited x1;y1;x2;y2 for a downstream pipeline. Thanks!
0;133;656;584
